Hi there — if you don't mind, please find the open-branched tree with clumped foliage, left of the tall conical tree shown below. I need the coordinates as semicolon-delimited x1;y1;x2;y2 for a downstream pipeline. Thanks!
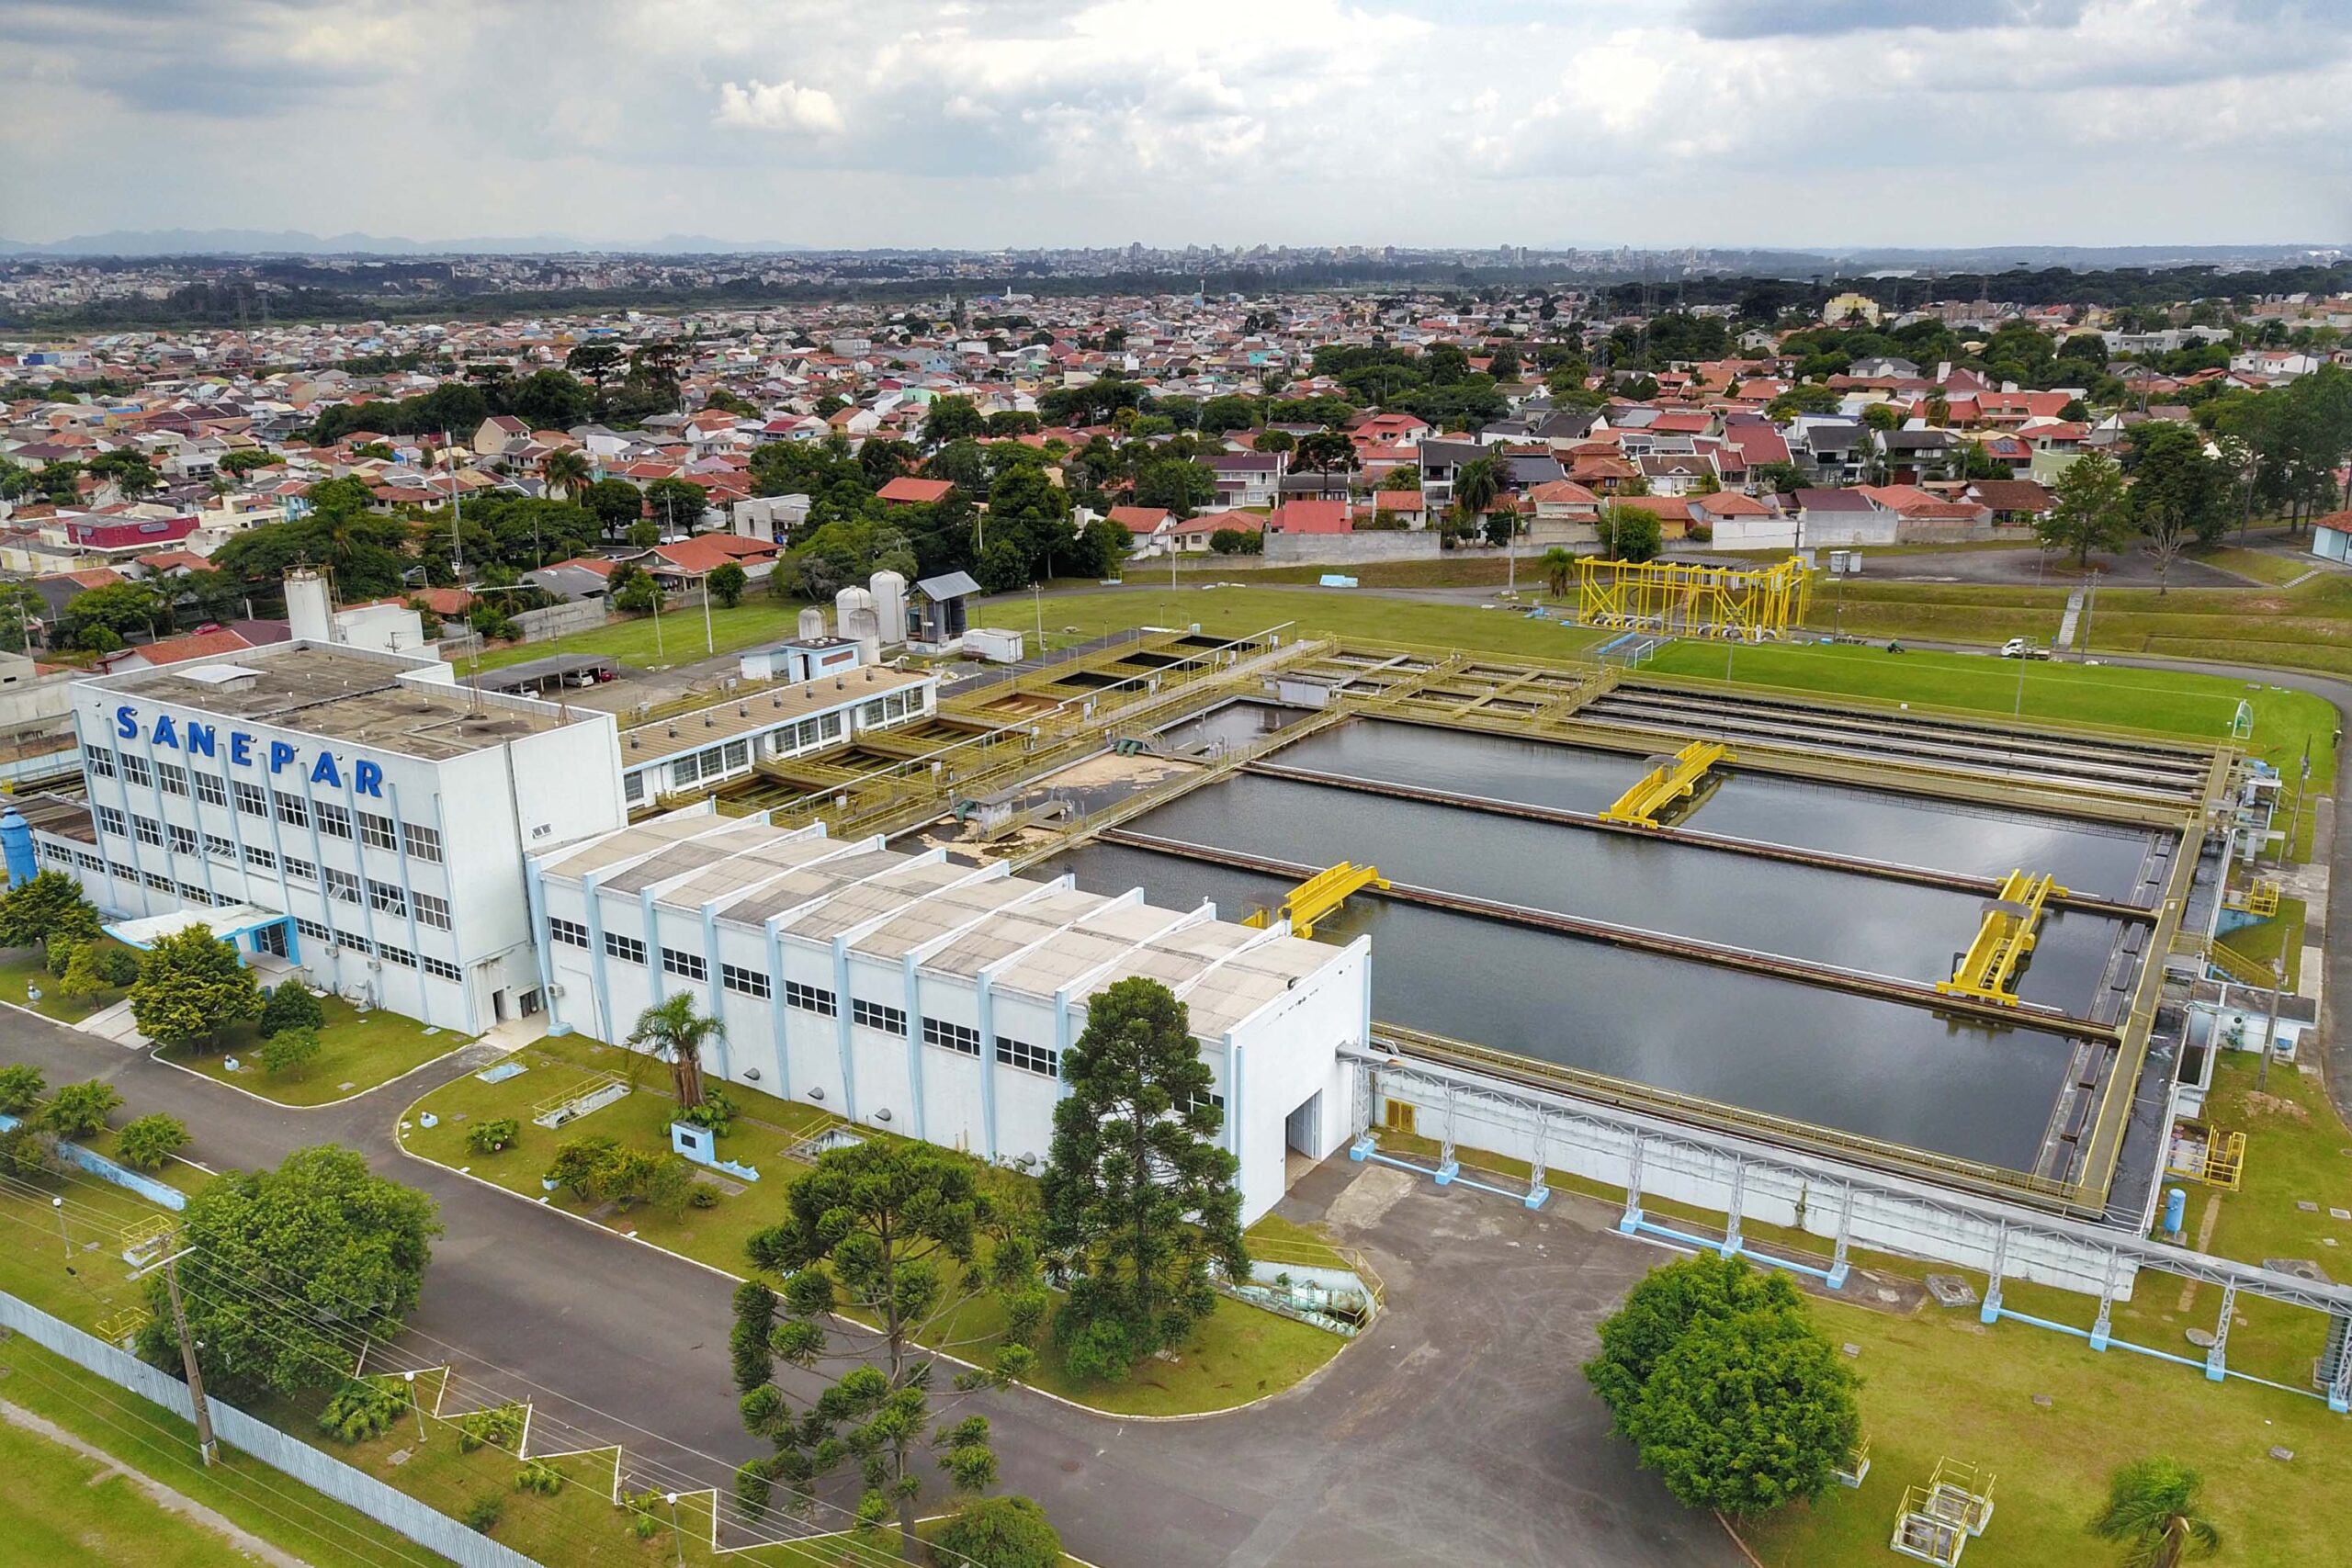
736;1140;1046;1561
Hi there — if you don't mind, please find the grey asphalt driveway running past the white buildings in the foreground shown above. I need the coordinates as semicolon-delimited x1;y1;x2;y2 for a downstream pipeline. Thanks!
0;1010;1738;1568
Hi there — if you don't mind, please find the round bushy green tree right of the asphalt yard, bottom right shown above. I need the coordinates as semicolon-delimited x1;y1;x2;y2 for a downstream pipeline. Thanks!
1585;1253;1860;1514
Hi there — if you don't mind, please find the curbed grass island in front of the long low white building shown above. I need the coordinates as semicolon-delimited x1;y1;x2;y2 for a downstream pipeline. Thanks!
400;1037;1343;1416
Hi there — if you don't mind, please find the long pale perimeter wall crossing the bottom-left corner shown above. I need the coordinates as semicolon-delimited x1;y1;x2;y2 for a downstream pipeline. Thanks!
0;1293;538;1568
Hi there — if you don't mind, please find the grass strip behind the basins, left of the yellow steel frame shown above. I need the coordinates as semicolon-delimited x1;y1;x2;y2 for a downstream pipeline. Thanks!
1045;587;1601;659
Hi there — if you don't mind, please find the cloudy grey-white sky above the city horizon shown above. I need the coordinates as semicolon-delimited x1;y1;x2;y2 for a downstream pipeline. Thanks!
0;0;2352;247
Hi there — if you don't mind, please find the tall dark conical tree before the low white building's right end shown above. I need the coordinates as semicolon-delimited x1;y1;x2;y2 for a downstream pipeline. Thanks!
1040;976;1249;1380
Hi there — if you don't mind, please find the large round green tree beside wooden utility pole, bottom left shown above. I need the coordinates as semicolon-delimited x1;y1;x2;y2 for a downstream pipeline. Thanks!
139;1145;440;1399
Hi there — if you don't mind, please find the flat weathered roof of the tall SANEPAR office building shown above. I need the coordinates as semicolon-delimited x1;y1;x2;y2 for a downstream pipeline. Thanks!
96;644;605;761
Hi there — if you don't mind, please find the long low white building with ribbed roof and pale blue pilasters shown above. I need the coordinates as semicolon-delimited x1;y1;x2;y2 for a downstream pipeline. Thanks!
532;807;1371;1220
